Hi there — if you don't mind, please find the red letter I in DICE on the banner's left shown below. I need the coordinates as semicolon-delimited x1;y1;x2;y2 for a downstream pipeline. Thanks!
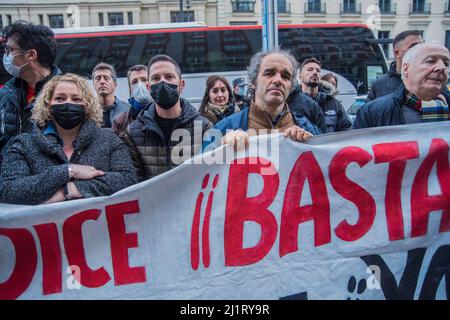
34;223;62;295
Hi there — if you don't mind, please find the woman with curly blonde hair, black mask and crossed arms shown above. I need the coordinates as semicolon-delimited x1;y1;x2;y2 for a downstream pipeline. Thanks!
0;73;137;204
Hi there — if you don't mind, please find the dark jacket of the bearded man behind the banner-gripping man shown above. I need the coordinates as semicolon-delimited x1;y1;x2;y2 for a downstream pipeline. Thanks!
314;91;352;133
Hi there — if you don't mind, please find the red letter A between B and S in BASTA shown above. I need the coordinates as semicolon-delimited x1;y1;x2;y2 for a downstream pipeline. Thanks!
280;151;331;257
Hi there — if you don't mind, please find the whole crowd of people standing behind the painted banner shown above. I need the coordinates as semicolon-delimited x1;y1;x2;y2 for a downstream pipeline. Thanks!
0;21;450;204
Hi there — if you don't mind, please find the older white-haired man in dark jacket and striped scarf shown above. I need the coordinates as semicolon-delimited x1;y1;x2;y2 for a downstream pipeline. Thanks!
353;43;450;129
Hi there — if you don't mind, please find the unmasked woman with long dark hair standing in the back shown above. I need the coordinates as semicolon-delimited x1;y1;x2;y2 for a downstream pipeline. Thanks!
199;75;240;124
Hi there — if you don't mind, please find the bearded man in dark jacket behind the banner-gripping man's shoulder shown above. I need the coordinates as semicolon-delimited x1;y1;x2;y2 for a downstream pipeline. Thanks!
299;58;352;133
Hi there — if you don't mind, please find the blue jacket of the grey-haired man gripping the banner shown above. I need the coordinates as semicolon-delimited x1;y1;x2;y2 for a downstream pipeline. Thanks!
203;108;321;150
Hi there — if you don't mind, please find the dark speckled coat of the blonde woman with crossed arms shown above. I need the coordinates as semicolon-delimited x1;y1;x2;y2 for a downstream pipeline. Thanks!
0;121;137;204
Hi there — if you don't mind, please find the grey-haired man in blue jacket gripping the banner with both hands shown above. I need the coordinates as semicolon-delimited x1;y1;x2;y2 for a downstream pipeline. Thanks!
207;49;320;150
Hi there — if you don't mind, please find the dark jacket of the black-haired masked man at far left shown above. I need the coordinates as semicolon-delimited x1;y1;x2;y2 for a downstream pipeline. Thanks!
0;66;61;155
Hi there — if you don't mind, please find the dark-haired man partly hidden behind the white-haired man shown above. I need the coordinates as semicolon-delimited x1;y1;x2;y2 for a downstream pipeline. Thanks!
366;30;423;102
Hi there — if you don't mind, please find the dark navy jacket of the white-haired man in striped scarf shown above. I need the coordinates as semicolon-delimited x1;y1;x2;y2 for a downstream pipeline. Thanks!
353;84;450;129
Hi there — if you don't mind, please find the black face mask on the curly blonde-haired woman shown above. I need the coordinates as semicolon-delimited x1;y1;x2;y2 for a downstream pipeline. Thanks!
50;103;86;130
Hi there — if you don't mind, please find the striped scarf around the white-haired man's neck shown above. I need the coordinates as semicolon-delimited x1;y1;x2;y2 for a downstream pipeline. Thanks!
403;91;450;122
